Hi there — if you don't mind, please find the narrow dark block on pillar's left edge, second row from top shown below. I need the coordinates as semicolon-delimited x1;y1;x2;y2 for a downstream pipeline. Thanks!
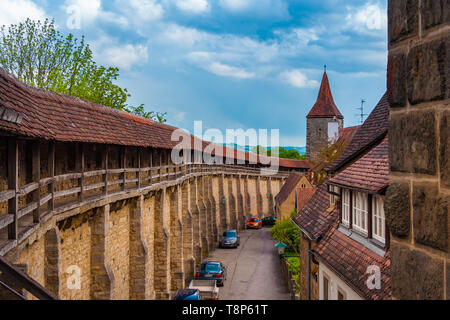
387;53;407;108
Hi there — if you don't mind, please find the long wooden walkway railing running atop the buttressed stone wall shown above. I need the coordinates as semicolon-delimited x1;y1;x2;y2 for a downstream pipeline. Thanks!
0;140;288;256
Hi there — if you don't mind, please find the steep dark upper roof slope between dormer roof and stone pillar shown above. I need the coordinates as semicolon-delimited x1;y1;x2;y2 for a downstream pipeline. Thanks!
326;94;389;171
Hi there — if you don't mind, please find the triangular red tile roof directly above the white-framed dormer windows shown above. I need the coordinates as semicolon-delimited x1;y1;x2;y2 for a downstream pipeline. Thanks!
329;136;389;193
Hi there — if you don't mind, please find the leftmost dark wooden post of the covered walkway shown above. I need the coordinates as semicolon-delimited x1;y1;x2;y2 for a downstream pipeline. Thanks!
8;138;19;240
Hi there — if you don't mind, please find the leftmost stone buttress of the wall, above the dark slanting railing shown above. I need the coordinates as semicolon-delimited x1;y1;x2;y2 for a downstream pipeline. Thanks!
44;228;61;297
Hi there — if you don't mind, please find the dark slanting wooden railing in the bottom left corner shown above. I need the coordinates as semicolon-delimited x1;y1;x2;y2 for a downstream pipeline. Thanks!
0;257;58;300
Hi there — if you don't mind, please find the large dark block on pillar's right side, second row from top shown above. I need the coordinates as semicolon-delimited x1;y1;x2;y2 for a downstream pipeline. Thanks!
407;37;450;104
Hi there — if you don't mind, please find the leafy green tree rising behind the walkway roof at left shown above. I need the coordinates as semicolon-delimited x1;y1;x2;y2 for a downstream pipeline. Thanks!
0;19;166;122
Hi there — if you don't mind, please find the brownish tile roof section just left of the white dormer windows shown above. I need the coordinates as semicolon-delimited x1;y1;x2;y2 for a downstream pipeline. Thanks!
293;183;339;240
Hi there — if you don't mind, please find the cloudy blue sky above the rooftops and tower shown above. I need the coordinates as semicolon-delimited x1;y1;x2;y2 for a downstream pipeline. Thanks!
0;0;387;146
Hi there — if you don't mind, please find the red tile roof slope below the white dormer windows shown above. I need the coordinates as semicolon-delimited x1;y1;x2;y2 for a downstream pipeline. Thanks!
312;226;392;300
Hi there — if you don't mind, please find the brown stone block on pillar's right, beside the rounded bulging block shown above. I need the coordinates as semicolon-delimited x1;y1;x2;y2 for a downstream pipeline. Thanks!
413;183;450;252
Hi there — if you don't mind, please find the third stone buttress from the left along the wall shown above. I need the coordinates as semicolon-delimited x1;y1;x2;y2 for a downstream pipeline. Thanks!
129;196;150;300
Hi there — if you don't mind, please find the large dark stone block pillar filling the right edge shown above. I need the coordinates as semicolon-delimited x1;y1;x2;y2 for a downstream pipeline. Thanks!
385;0;450;299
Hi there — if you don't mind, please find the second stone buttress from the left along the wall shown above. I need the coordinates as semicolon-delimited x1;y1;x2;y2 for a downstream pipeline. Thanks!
90;204;114;300
